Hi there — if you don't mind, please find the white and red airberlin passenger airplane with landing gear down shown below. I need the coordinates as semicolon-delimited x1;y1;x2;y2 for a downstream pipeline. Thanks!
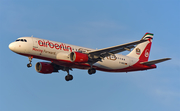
9;33;171;81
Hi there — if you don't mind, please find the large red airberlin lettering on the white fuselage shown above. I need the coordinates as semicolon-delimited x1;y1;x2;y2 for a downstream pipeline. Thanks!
38;40;72;52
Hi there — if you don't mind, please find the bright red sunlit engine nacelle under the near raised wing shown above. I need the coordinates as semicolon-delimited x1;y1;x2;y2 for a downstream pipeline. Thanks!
70;52;89;63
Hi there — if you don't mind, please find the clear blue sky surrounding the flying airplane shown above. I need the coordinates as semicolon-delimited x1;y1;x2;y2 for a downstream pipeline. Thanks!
0;0;180;111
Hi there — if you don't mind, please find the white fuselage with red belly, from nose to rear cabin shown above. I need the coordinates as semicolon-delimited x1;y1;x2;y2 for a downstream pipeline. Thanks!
9;37;139;72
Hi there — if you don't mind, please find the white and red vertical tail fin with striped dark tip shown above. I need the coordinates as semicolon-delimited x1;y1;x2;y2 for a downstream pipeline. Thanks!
127;33;153;61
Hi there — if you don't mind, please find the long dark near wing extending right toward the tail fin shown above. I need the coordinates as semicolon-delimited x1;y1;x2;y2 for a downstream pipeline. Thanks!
87;40;147;62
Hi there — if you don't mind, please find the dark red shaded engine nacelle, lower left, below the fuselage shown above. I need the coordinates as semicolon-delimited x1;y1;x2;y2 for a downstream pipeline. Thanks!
35;62;54;74
